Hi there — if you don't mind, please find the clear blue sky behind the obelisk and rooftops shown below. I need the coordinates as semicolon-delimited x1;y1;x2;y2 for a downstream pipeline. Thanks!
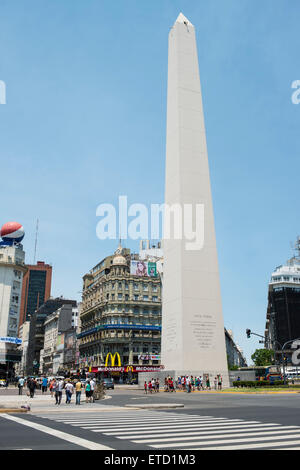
0;0;300;359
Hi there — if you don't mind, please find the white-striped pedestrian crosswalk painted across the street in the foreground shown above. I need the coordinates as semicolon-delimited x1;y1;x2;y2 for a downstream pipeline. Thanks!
39;410;300;450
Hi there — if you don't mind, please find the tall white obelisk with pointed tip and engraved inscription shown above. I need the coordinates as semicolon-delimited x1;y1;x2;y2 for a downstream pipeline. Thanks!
161;13;228;386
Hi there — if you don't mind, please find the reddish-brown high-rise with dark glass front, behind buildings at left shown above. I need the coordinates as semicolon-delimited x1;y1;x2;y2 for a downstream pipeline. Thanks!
19;261;52;325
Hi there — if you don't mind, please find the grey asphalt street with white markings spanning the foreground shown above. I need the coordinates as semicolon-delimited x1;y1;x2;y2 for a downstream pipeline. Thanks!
0;388;300;451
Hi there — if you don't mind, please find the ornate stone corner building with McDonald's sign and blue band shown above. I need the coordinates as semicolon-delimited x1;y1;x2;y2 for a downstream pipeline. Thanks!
78;246;161;379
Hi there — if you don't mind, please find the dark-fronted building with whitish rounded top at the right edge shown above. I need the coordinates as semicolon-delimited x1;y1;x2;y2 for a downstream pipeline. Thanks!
265;237;300;362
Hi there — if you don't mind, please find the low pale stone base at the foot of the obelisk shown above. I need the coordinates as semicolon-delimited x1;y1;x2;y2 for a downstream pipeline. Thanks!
138;369;230;390
